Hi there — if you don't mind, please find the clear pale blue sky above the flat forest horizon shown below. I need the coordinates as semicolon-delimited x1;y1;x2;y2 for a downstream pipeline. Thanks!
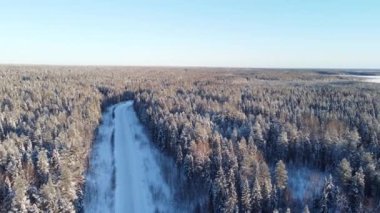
0;0;380;68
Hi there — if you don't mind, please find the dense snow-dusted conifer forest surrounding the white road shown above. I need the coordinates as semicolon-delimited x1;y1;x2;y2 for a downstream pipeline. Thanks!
0;65;380;213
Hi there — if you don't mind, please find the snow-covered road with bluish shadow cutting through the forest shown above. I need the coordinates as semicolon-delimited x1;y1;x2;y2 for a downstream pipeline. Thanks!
84;101;173;213
